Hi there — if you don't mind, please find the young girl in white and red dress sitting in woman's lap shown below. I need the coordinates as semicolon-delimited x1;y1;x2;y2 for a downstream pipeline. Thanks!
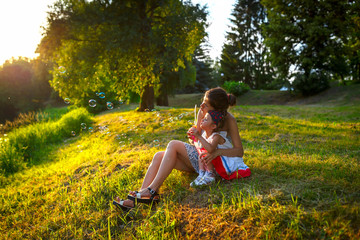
189;110;250;186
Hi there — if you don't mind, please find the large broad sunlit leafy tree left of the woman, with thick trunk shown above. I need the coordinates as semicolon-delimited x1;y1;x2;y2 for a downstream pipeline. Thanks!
38;0;206;110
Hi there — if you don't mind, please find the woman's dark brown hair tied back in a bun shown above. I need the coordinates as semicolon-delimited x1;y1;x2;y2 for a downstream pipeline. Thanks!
204;87;236;115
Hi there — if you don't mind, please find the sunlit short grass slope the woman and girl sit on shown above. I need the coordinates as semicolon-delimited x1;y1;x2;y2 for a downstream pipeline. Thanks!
0;94;360;239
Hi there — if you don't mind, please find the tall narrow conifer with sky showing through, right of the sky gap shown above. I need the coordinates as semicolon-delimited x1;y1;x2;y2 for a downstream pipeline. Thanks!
221;0;274;89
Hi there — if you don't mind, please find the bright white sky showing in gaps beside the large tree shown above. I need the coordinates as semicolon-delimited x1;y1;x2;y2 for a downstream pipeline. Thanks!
0;0;236;65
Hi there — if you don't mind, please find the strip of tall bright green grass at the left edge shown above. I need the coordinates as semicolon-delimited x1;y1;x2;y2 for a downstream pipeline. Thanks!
0;108;92;174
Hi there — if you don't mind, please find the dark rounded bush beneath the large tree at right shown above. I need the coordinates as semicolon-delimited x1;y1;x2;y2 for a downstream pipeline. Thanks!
292;71;330;96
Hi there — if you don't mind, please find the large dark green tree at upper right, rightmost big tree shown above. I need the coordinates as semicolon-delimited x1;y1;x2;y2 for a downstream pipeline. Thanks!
262;0;350;95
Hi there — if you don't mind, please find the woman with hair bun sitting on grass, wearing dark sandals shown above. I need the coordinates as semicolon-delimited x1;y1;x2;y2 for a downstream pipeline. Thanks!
113;87;244;210
